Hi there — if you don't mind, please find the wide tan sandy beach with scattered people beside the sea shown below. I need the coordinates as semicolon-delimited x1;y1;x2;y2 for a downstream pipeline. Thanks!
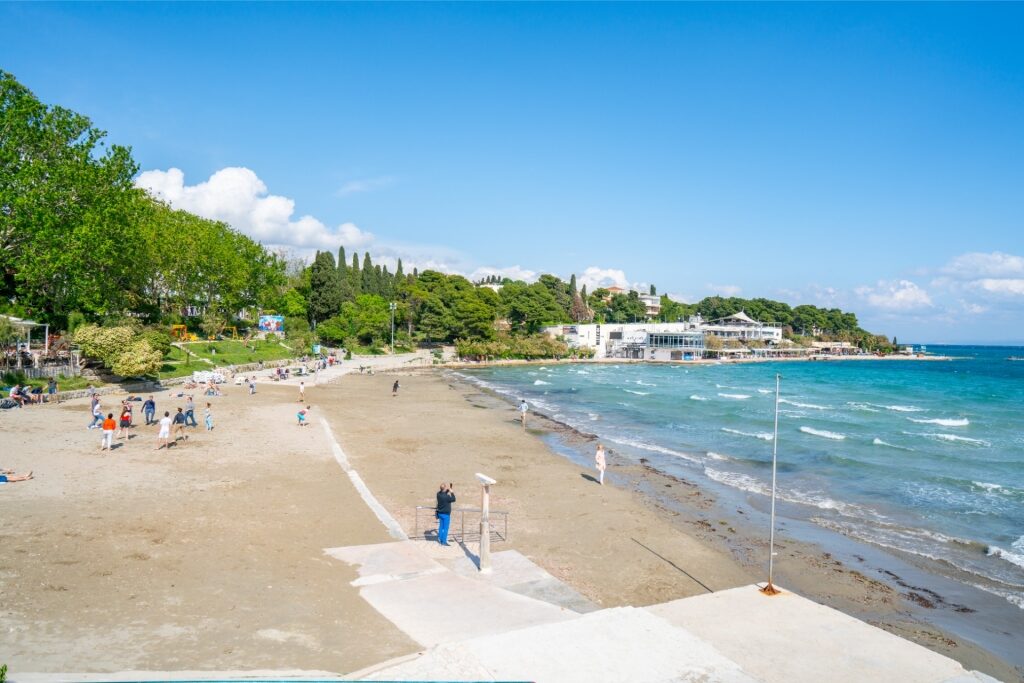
0;370;1020;681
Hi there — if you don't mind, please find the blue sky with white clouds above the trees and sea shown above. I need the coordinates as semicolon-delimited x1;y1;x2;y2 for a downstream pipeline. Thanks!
0;3;1024;342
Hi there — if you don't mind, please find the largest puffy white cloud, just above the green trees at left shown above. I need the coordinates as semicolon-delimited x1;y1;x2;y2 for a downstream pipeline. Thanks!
135;167;374;253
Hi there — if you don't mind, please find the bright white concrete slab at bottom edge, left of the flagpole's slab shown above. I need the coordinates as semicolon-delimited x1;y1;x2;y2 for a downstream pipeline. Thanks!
353;607;756;683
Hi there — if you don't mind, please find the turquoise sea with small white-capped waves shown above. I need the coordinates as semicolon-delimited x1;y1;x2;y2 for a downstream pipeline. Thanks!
463;346;1024;609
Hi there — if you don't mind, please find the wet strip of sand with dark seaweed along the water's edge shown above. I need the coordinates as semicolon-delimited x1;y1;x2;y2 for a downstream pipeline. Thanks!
434;374;1024;680
